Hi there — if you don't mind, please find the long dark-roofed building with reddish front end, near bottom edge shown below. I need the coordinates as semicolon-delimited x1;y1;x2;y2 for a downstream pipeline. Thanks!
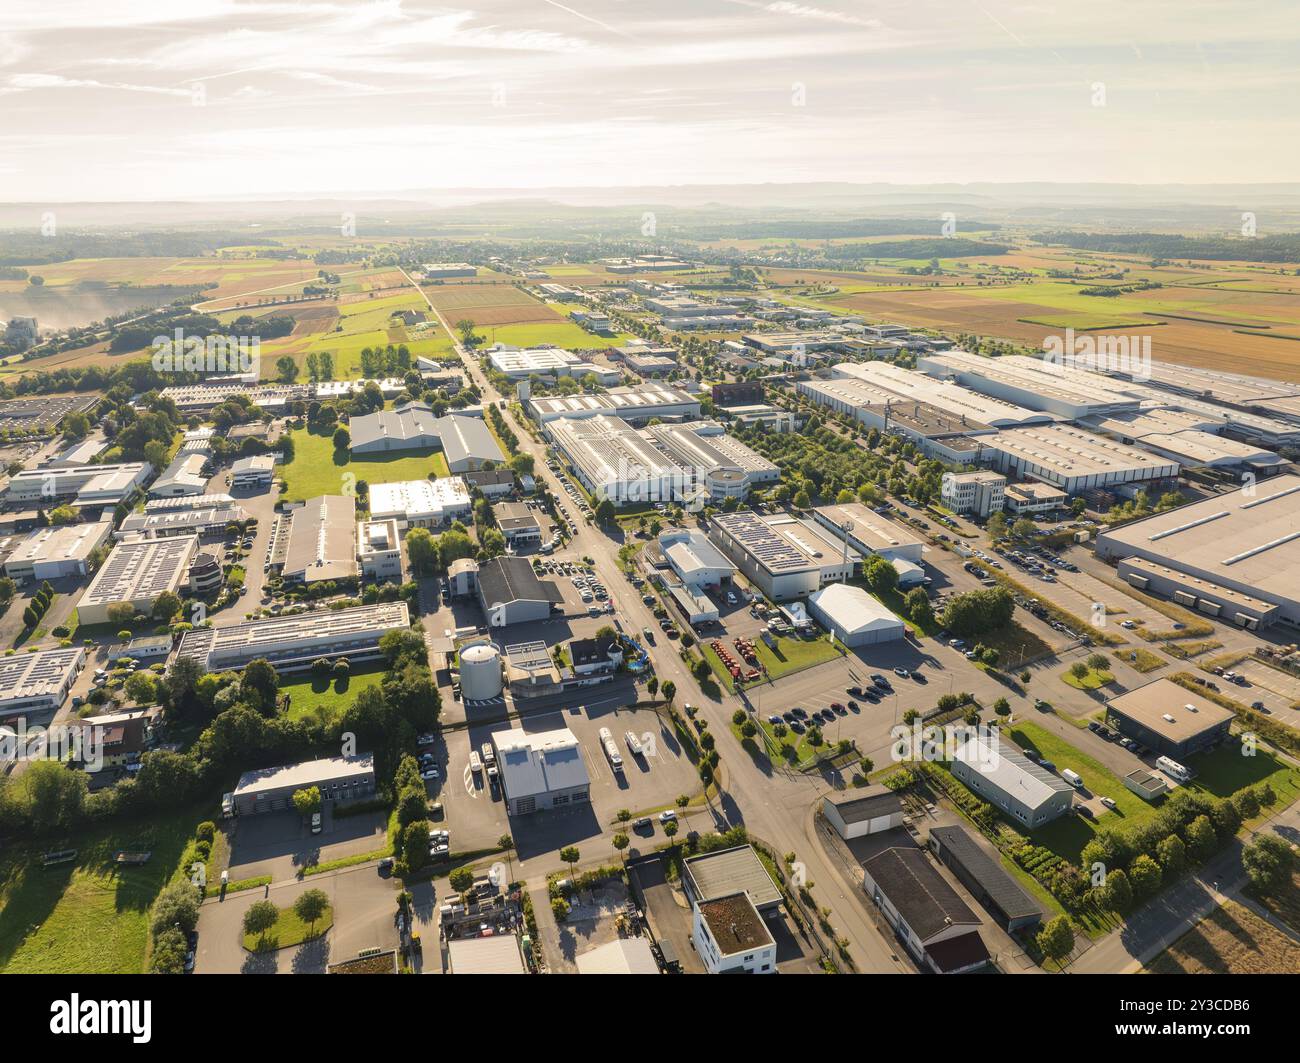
862;846;989;975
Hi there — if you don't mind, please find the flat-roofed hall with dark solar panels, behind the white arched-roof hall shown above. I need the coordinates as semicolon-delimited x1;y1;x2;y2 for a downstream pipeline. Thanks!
709;512;862;602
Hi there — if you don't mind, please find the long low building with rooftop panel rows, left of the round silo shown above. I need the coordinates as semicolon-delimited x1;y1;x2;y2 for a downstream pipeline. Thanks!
177;602;411;672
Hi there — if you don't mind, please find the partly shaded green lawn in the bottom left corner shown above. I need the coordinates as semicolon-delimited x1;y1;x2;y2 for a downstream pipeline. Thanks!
0;807;212;975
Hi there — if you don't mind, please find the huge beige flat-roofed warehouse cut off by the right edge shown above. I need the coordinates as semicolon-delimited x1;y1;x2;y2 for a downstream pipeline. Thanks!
1097;474;1300;628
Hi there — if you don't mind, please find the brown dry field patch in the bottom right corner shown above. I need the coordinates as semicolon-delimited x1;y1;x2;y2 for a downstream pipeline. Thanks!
1144;901;1300;975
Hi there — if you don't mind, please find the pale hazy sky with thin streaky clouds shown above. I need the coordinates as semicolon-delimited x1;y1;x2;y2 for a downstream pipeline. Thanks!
0;0;1300;201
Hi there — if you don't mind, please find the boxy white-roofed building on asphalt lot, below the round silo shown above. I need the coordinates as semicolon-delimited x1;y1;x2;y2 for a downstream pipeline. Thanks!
491;728;592;816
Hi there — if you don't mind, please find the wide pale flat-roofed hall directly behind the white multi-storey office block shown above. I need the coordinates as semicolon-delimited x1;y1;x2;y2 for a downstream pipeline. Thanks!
980;425;1179;495
